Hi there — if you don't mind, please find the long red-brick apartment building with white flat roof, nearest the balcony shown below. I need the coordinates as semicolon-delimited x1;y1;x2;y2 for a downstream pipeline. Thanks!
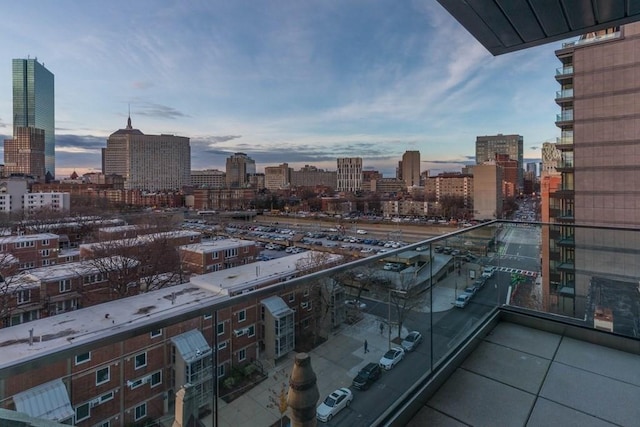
0;253;345;427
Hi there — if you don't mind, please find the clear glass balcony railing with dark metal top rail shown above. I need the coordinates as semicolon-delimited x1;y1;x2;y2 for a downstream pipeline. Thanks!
0;219;640;426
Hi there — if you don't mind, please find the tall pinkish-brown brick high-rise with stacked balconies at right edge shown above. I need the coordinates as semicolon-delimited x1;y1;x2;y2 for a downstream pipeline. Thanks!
543;23;640;316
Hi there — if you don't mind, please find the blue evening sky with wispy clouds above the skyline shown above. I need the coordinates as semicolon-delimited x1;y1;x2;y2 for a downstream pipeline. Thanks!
0;0;560;178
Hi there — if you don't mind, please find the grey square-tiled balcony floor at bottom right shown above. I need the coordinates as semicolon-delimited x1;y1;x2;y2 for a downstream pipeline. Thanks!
408;322;640;427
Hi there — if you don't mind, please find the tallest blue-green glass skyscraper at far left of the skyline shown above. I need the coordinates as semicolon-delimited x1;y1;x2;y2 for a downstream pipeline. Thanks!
13;59;56;178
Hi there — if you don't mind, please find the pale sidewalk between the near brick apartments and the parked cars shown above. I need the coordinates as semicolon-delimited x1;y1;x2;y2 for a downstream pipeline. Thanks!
218;264;479;427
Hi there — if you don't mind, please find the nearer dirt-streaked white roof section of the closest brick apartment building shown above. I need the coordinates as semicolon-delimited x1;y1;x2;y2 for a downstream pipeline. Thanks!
0;283;228;369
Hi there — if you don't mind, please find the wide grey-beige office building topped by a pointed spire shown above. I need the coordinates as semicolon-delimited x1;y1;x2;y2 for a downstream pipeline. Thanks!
103;117;191;191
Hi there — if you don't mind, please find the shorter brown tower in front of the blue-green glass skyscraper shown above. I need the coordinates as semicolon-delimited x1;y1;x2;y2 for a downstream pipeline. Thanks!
4;126;45;182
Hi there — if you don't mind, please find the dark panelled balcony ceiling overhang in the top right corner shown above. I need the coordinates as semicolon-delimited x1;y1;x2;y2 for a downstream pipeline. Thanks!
438;0;640;55
